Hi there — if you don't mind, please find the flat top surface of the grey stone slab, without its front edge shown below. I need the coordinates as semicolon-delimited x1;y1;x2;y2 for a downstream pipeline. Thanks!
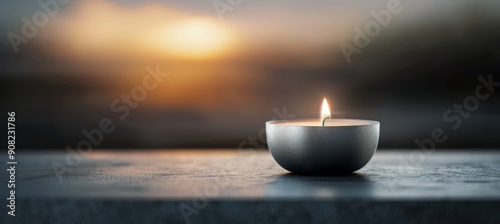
2;150;500;200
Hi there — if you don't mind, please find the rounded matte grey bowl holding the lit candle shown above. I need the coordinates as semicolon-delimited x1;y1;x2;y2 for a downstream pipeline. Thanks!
266;119;380;175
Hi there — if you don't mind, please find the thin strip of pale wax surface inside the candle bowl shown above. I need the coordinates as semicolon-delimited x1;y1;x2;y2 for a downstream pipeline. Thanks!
273;119;378;127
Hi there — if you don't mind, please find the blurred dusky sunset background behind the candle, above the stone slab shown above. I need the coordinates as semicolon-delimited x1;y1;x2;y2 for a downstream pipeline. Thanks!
0;0;500;149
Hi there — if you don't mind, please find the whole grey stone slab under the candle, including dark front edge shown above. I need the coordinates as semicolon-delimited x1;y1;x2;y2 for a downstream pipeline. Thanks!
1;149;500;223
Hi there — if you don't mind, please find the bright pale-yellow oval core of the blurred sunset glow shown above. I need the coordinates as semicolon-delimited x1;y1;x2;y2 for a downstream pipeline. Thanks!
148;19;232;58
